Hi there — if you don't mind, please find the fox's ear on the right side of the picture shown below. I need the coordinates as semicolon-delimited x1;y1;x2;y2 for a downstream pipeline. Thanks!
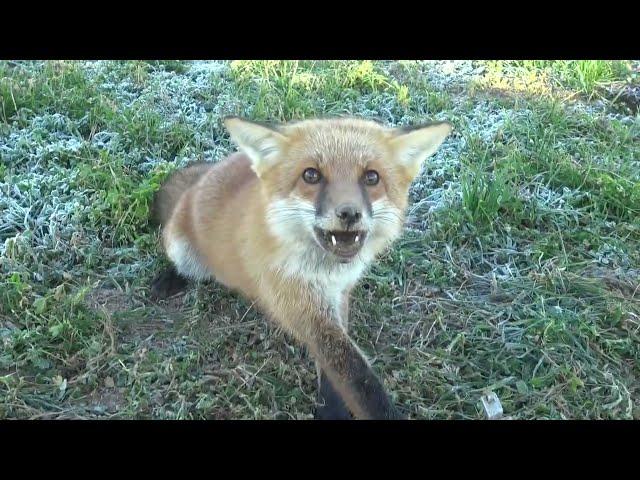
389;122;453;177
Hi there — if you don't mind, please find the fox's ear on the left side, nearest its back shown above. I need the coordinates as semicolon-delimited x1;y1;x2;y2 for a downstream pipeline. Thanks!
224;117;287;176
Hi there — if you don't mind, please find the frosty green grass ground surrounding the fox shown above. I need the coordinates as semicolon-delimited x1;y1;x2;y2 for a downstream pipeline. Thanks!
0;61;640;419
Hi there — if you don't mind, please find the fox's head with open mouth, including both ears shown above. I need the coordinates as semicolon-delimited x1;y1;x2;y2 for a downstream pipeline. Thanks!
224;117;452;263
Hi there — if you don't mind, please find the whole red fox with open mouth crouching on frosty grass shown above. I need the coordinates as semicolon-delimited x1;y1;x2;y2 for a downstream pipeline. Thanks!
151;117;452;419
